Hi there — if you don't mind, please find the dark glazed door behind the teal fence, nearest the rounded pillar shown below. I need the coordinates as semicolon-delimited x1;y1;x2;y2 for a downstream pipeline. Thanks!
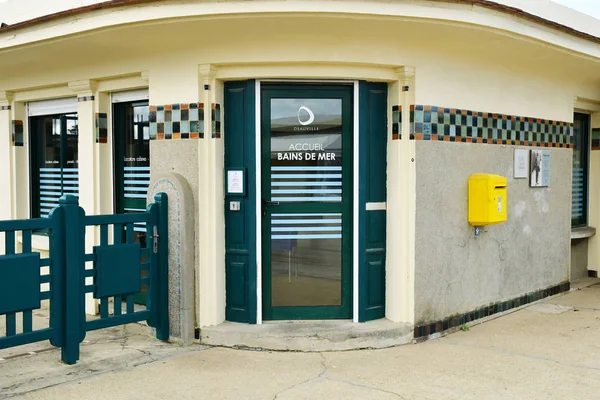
113;101;150;304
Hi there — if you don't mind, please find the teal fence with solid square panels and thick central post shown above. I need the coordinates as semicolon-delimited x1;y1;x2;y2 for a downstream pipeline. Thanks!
0;193;169;364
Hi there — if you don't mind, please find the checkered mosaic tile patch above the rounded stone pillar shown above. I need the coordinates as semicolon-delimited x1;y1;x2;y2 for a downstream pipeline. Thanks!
149;103;204;140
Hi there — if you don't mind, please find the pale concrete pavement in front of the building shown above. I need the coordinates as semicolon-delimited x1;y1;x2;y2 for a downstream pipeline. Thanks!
0;281;600;400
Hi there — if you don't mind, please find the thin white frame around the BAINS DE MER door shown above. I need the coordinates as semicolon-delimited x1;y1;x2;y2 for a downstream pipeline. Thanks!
255;79;359;324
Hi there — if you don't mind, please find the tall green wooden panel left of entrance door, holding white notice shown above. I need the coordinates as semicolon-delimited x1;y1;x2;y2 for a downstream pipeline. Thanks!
224;80;257;323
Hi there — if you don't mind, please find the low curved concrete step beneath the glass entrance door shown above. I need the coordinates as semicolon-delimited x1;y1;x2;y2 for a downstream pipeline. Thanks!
200;318;413;352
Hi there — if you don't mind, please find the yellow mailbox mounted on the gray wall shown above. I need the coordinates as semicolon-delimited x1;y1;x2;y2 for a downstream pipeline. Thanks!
469;174;506;226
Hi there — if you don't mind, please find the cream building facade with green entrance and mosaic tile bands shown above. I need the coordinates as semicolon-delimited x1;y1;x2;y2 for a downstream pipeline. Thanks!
0;0;600;337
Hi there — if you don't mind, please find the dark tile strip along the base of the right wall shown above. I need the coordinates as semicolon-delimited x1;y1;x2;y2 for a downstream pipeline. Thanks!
414;282;571;339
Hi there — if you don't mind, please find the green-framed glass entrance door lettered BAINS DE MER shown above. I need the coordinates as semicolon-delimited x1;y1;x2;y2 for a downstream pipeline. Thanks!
261;84;353;320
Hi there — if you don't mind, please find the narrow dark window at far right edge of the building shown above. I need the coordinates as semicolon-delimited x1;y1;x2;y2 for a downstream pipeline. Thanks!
571;113;590;227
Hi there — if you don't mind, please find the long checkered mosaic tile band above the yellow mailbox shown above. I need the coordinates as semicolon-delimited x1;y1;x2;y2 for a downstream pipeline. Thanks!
392;104;573;148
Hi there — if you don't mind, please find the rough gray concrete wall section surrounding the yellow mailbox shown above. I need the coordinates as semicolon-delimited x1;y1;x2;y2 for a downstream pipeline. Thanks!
415;141;572;324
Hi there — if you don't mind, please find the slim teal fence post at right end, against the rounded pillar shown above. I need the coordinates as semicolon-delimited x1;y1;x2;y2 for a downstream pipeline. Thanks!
154;193;169;341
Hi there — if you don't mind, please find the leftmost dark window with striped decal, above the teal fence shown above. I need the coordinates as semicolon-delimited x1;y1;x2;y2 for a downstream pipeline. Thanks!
29;113;79;218
